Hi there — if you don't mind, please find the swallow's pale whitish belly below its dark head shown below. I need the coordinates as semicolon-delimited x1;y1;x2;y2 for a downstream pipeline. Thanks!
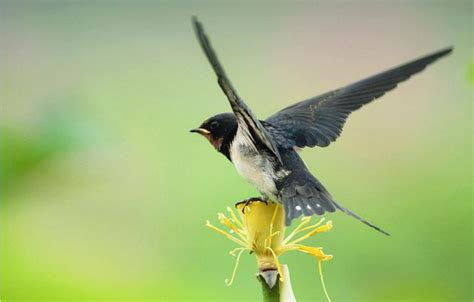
230;128;276;197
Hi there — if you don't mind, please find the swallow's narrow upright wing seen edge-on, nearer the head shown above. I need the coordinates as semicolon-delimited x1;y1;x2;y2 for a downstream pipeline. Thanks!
193;17;281;162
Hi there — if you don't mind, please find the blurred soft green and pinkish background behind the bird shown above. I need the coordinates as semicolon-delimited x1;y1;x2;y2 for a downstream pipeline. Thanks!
0;1;473;301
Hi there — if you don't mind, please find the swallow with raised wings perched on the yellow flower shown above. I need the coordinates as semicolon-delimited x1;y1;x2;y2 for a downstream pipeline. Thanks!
190;16;453;236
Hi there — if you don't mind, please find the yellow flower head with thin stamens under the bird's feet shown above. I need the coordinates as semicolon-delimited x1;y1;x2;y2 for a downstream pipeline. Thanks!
206;202;332;300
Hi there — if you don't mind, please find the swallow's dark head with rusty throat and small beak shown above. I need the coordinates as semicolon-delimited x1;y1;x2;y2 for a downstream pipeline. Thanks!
191;113;237;152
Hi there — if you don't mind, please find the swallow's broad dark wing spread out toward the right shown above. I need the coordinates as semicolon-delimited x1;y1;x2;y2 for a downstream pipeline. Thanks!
266;48;452;148
